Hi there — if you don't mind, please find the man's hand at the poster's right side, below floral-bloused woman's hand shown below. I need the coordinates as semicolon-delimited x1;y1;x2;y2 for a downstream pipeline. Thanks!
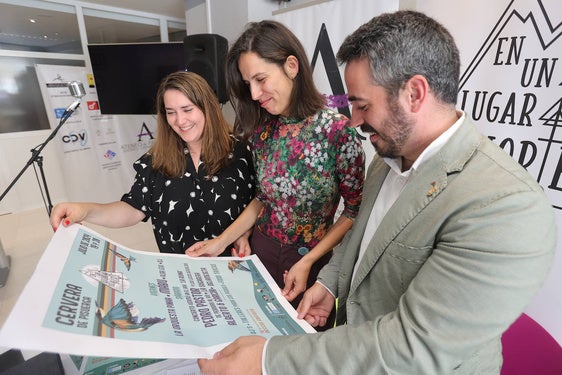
297;282;335;327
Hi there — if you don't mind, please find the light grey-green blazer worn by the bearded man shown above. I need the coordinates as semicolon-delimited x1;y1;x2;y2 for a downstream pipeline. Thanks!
265;116;557;375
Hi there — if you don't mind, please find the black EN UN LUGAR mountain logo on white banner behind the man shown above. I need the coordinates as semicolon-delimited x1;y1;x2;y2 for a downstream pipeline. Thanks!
458;0;562;209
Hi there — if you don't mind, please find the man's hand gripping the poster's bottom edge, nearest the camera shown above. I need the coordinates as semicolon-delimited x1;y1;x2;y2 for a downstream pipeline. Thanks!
197;336;266;375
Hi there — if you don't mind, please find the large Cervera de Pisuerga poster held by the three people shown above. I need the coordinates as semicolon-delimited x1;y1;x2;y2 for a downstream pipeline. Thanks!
0;224;314;358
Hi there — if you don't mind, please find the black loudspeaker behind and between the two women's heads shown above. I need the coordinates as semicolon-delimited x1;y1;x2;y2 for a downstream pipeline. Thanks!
183;34;228;103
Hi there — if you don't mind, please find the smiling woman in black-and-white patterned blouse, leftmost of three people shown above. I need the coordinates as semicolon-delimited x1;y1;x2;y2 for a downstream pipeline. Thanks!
51;72;255;255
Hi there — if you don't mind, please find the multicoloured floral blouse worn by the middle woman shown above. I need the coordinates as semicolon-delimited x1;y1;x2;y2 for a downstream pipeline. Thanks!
253;109;365;249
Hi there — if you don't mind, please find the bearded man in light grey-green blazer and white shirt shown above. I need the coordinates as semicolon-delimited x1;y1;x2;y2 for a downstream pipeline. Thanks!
199;11;557;375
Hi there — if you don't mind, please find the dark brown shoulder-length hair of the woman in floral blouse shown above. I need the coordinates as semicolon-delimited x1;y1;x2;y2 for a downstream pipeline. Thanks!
226;20;326;138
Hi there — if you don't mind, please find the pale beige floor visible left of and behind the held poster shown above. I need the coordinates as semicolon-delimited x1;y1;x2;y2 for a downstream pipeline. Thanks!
0;208;158;353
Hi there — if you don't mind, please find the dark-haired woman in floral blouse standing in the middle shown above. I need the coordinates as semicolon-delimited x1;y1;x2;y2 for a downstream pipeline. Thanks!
186;21;364;307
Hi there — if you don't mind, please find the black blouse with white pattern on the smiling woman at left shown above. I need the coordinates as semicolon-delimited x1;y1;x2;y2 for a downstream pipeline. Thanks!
121;140;255;255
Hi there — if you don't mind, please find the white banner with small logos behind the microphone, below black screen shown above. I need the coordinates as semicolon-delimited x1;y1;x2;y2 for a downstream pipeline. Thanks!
35;64;156;206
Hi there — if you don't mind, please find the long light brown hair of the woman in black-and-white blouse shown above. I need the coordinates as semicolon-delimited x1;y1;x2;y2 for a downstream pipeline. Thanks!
148;72;234;181
